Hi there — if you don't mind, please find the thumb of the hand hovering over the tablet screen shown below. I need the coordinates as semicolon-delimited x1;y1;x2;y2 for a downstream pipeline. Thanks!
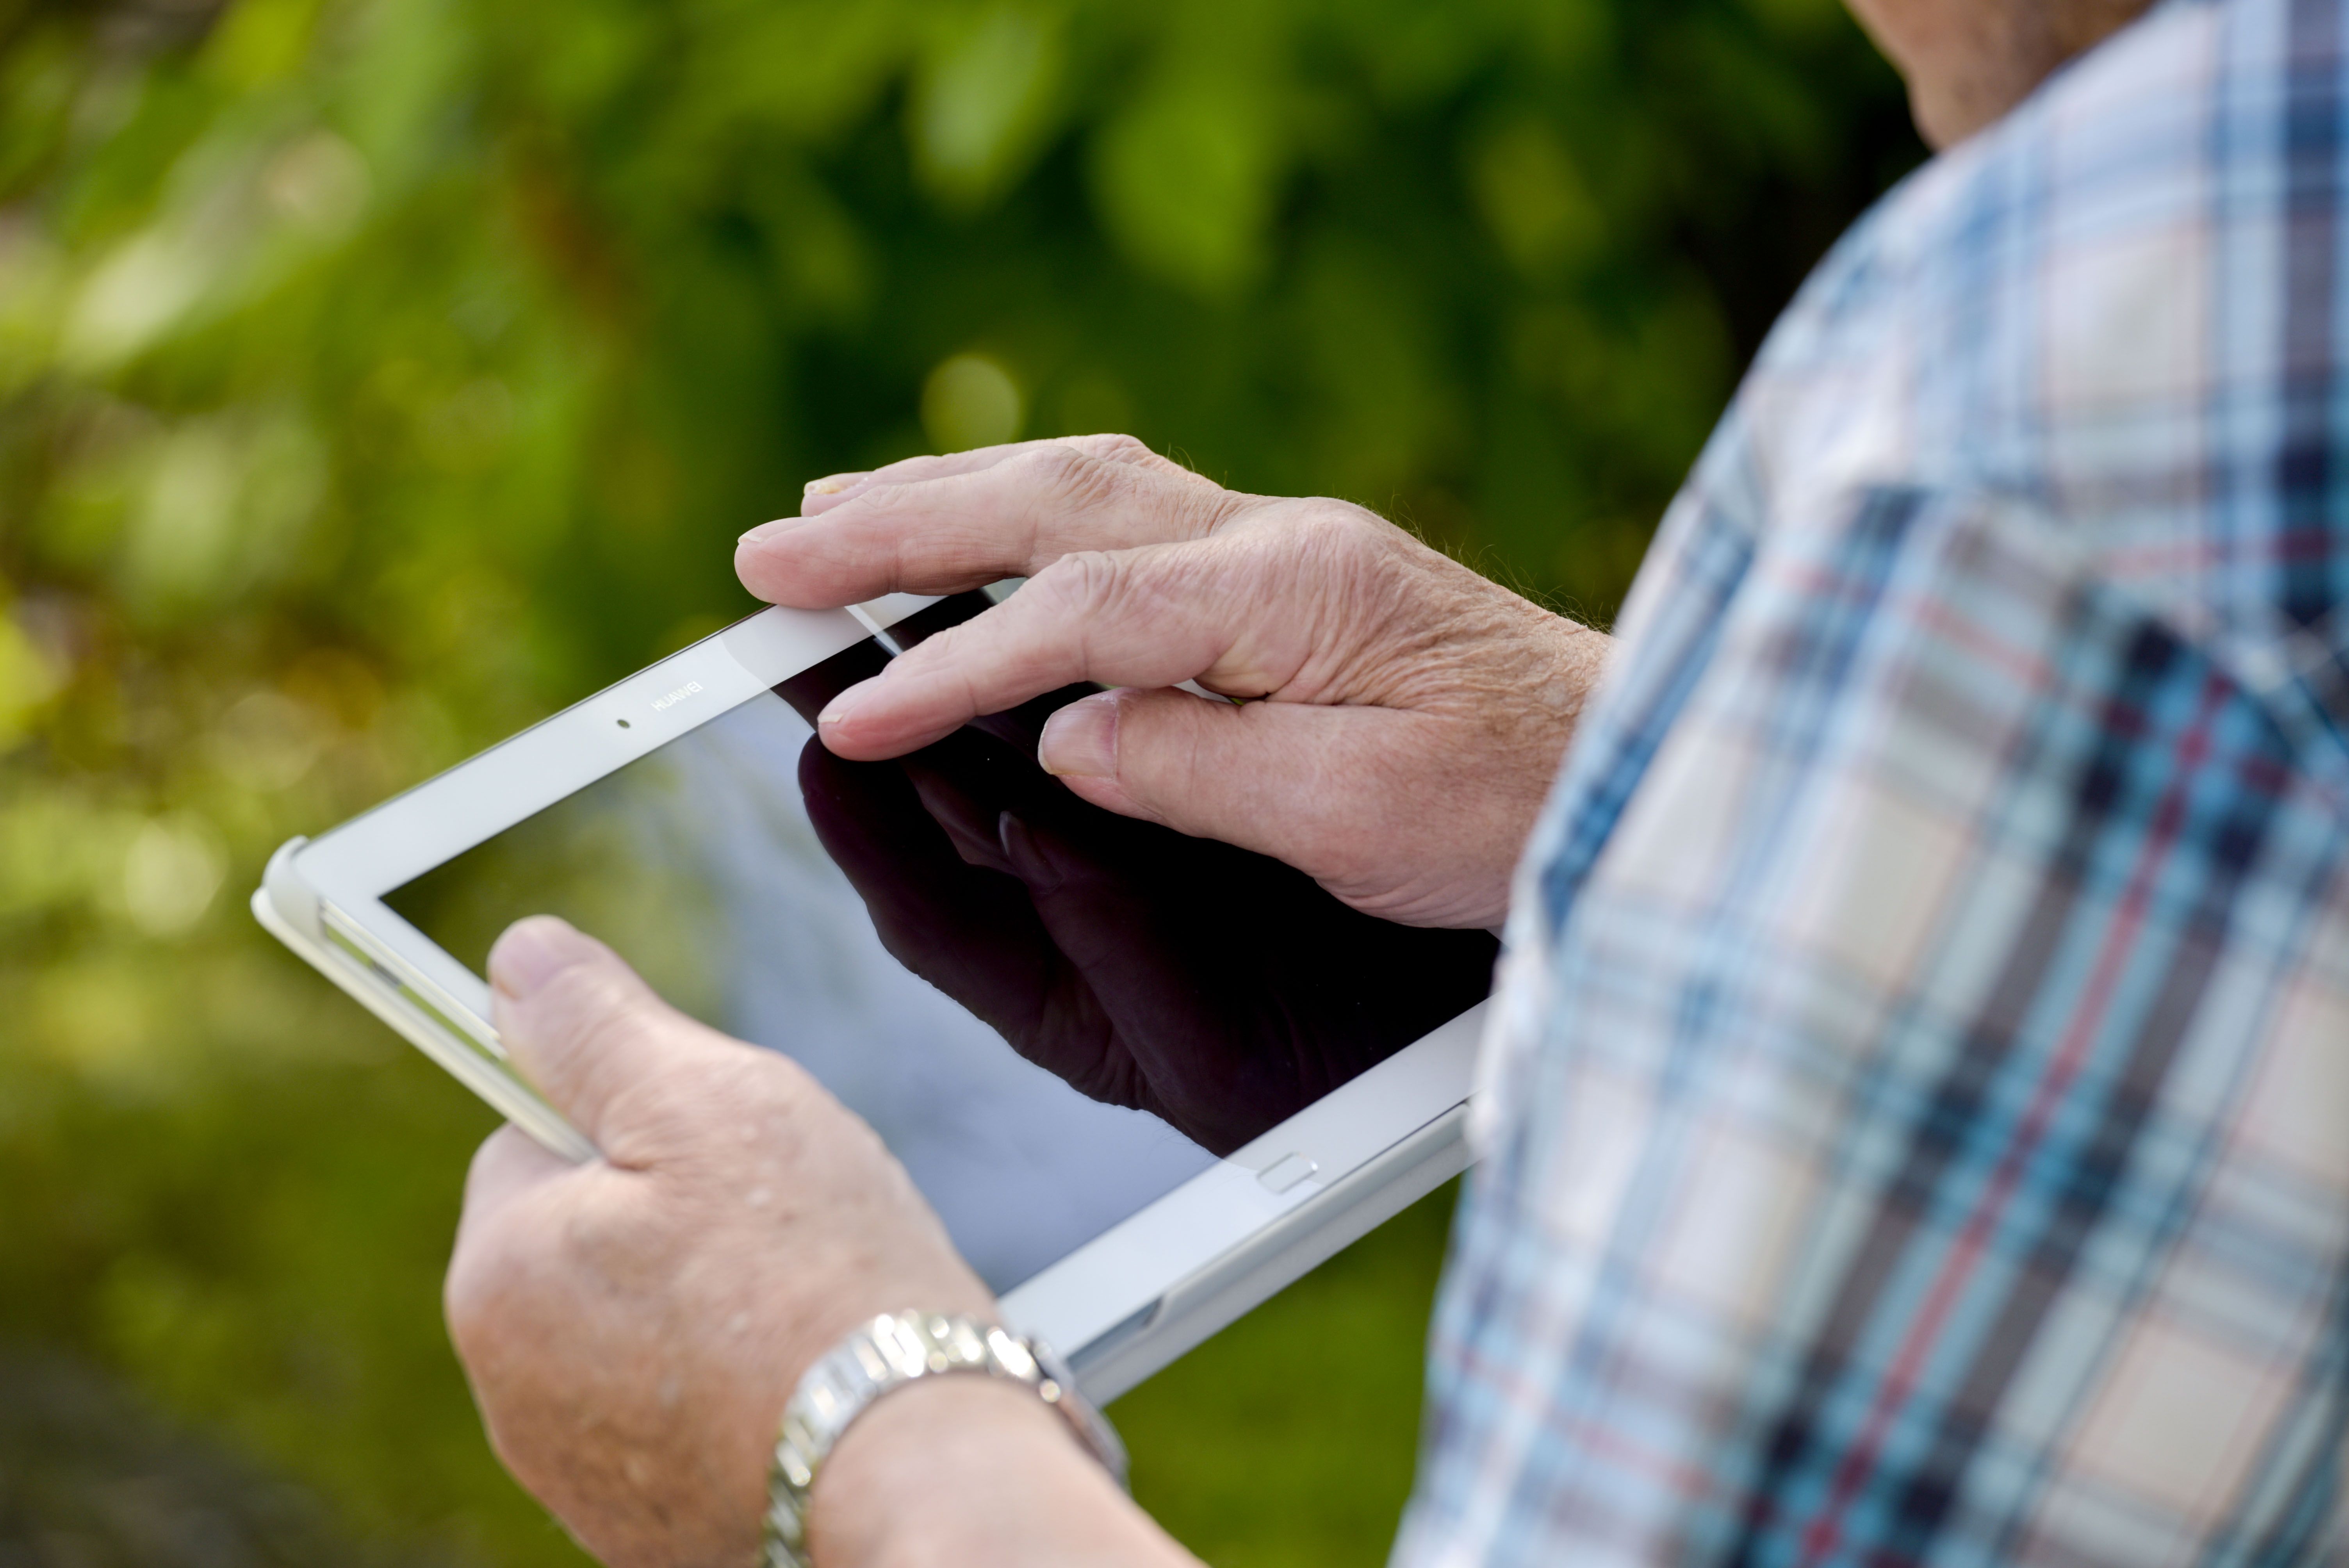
1036;688;1412;897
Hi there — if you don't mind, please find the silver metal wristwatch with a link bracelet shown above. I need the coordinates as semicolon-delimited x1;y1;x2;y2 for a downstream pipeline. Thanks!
759;1312;1125;1568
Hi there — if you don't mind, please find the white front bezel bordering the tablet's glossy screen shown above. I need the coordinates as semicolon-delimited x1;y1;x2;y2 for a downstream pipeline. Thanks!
256;594;1485;1380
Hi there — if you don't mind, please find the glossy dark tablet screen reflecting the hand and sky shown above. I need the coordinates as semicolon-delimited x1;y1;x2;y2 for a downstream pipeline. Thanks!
383;594;1494;1291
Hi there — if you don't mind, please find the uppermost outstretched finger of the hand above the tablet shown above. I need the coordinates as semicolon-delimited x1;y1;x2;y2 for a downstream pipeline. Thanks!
735;444;1252;610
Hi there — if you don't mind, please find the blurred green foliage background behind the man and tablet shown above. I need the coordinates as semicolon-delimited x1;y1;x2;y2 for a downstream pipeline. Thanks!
0;0;1921;1568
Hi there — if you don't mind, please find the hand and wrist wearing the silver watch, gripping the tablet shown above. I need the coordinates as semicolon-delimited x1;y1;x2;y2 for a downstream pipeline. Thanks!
446;918;1186;1568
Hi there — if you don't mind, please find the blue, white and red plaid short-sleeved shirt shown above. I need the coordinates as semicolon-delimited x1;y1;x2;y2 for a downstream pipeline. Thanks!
1398;0;2349;1568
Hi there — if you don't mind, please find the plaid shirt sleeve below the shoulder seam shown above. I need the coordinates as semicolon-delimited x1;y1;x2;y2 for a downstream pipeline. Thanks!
1398;491;2349;1568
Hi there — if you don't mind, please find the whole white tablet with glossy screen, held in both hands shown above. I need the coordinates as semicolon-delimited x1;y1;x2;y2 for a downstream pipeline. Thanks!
254;594;1494;1399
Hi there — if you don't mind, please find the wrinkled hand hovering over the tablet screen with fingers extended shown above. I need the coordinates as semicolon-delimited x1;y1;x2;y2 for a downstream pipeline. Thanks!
735;437;1607;927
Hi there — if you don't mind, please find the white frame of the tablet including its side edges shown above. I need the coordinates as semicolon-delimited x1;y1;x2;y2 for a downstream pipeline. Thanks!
254;594;1485;1399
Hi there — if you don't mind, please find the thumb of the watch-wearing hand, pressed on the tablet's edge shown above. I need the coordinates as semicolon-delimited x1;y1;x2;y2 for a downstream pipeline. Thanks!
488;916;712;1162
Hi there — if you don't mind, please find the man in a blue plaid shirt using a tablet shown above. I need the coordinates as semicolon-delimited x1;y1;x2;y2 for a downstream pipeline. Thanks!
449;0;2349;1568
